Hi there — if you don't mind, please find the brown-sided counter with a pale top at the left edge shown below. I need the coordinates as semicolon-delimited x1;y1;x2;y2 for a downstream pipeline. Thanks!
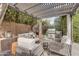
0;38;12;54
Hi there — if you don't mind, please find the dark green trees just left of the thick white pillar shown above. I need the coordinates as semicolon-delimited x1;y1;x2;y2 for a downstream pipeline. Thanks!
55;16;67;35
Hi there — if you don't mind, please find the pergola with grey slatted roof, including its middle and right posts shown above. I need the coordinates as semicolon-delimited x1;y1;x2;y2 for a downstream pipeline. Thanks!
0;3;79;55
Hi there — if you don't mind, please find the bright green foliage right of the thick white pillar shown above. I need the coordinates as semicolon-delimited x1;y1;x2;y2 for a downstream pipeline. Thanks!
72;10;79;43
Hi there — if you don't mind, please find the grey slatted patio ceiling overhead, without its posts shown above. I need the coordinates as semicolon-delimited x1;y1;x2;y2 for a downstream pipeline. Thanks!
9;3;79;18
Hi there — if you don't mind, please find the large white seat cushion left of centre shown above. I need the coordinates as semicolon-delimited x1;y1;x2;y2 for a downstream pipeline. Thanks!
18;37;35;49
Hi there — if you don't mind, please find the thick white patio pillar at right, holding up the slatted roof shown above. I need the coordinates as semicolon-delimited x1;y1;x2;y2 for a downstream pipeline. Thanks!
66;14;72;55
